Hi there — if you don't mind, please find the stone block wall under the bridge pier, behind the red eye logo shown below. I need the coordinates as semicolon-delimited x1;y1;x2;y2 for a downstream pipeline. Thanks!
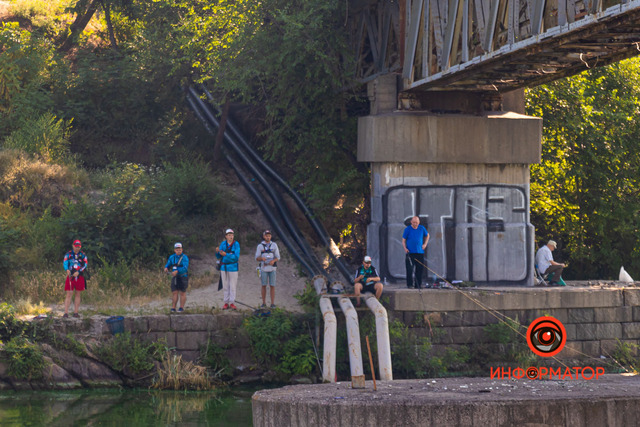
389;287;640;359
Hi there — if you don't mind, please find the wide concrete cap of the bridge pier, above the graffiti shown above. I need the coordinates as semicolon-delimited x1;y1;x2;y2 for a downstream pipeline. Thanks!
358;112;542;164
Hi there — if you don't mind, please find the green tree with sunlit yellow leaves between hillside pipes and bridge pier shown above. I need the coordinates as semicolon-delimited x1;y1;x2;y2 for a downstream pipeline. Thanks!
135;0;369;251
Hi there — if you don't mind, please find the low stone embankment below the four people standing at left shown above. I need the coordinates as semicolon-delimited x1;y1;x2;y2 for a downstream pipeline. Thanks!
0;313;250;390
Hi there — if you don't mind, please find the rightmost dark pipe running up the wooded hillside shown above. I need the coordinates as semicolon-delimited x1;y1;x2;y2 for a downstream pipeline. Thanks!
201;85;353;283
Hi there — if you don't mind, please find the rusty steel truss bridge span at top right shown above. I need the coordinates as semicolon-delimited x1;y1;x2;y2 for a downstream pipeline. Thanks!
349;0;640;92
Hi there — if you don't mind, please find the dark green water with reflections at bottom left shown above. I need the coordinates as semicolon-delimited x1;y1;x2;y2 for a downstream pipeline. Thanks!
0;390;252;427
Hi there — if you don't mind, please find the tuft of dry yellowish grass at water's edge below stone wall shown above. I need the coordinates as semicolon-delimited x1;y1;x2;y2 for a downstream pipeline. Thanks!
152;351;215;390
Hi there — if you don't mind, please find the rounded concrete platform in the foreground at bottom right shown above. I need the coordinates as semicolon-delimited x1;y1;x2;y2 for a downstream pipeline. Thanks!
252;374;640;427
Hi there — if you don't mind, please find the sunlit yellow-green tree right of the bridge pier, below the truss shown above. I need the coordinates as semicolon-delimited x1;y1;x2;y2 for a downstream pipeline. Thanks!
527;58;640;279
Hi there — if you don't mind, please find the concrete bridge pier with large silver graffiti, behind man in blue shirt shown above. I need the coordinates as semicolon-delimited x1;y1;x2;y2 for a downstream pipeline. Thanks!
358;75;542;285
